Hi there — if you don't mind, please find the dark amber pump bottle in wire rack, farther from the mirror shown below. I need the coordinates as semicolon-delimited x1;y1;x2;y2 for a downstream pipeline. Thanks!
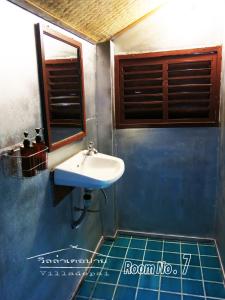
20;131;37;177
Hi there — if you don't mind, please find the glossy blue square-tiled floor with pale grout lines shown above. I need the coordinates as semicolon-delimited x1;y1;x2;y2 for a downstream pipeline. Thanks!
75;235;225;300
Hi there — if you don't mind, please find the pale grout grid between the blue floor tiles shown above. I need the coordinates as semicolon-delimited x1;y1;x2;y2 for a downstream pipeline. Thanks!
76;236;223;300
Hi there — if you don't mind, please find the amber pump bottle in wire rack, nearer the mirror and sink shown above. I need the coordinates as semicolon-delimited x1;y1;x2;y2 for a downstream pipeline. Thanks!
33;128;47;170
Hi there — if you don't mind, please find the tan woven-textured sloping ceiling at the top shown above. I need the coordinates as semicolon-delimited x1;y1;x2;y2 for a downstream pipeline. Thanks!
23;0;165;43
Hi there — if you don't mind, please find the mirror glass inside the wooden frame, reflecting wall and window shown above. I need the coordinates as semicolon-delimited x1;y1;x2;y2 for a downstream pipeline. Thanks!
44;35;82;143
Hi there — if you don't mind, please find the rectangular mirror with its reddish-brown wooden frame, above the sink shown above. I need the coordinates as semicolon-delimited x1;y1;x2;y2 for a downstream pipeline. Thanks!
36;24;86;151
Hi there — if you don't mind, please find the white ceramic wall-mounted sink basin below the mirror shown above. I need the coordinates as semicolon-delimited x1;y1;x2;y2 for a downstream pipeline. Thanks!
54;150;125;189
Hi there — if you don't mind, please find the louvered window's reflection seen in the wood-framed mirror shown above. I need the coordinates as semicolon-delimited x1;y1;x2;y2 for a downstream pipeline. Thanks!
45;58;81;126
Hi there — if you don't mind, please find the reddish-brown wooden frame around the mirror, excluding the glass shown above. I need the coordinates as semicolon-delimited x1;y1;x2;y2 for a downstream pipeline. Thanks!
35;23;86;151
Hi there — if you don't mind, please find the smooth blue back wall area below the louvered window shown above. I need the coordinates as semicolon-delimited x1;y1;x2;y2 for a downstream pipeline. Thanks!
116;128;219;236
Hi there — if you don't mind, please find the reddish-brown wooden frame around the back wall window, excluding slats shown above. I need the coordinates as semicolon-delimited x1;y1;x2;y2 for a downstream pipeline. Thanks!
115;46;222;129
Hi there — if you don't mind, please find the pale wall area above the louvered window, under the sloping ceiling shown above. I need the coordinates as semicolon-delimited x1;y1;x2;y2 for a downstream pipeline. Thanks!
114;0;225;54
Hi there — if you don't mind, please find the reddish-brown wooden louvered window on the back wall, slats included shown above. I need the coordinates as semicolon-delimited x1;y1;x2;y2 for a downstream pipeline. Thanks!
115;47;221;128
